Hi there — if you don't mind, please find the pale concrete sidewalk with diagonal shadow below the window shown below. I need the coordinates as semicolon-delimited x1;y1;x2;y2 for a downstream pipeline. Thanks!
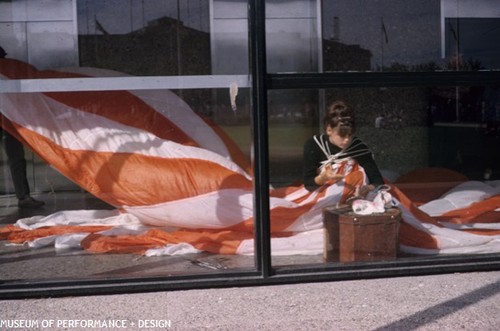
0;271;500;331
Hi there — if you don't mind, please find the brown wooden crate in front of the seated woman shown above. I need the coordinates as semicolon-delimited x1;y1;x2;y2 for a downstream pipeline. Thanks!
323;207;401;262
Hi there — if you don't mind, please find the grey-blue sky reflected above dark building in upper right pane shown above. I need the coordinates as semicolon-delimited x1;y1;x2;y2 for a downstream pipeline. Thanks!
323;0;441;67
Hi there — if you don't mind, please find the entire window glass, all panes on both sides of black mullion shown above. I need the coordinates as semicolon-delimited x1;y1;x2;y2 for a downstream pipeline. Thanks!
0;0;500;290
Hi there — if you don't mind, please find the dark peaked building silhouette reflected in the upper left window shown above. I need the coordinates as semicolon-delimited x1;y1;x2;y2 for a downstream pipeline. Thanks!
79;17;210;76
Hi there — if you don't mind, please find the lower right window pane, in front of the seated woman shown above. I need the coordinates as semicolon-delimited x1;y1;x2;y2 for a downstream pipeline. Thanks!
269;86;500;266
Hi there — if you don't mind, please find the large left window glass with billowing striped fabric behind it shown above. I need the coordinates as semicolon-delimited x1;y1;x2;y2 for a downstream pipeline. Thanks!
0;0;255;284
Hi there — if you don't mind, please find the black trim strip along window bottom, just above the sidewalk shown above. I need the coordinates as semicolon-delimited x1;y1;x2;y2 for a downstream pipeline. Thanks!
0;254;500;299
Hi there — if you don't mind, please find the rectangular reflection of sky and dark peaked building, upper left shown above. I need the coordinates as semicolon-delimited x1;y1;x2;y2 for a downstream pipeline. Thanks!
78;0;211;76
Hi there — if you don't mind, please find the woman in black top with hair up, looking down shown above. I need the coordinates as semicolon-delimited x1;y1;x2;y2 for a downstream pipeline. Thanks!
303;101;384;191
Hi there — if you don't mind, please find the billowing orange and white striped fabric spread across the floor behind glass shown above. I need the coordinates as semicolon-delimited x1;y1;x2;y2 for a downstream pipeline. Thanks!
0;59;500;255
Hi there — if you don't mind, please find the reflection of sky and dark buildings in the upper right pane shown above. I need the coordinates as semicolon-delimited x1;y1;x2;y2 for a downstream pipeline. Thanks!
322;0;500;71
